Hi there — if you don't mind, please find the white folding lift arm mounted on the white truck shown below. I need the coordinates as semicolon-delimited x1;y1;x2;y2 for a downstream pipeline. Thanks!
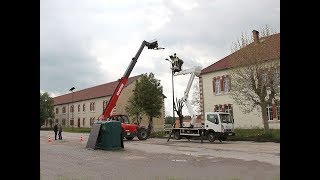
174;66;201;127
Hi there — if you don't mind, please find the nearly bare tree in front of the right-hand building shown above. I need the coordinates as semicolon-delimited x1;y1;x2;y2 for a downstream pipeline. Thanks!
230;26;280;131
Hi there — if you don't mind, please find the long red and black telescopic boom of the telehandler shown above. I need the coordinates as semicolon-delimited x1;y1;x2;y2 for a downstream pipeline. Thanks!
99;40;164;120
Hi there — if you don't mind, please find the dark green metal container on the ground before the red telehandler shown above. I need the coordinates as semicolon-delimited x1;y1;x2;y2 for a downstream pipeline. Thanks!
95;121;124;150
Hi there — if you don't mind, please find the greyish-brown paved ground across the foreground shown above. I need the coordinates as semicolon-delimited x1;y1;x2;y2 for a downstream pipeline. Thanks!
40;131;280;180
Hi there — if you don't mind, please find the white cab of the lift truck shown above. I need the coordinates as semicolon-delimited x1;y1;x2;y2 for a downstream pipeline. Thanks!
204;112;235;142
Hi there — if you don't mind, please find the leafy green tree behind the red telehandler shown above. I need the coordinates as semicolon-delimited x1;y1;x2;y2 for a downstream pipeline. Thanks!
128;73;163;136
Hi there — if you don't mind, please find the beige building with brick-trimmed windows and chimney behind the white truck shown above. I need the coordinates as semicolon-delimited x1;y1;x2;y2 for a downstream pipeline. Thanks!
199;31;280;129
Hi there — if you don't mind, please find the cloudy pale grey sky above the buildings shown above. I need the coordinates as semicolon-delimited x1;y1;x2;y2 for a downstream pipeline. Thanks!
40;0;280;116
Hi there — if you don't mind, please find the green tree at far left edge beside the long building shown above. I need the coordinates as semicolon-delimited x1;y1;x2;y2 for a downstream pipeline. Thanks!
40;92;54;127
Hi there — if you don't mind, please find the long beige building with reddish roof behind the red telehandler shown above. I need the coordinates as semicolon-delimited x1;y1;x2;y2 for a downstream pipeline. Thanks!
53;75;165;131
